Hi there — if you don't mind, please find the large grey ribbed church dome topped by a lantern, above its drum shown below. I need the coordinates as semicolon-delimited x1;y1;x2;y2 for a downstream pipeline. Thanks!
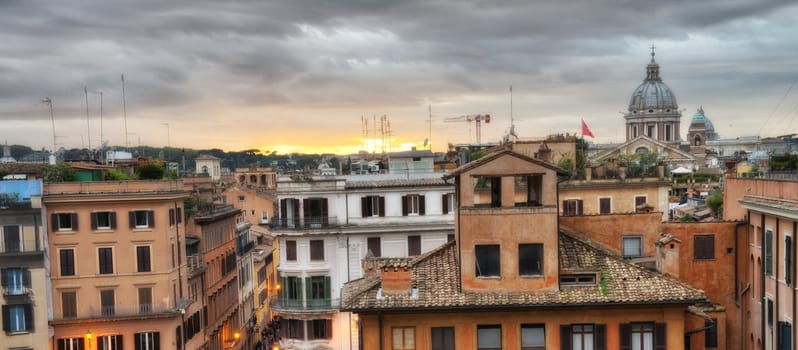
629;53;679;114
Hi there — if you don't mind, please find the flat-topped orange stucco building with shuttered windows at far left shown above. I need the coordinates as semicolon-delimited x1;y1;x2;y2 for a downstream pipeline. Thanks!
42;181;189;349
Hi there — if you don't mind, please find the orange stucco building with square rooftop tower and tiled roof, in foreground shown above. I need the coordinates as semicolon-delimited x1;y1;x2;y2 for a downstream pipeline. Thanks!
342;150;708;349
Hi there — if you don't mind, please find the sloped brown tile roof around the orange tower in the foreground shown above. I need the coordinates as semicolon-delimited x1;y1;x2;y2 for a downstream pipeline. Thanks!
342;232;708;311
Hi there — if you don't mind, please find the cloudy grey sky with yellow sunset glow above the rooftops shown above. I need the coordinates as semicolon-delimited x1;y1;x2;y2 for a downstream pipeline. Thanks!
0;0;798;154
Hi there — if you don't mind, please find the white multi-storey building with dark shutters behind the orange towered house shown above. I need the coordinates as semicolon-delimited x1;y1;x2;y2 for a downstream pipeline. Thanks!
271;174;455;349
